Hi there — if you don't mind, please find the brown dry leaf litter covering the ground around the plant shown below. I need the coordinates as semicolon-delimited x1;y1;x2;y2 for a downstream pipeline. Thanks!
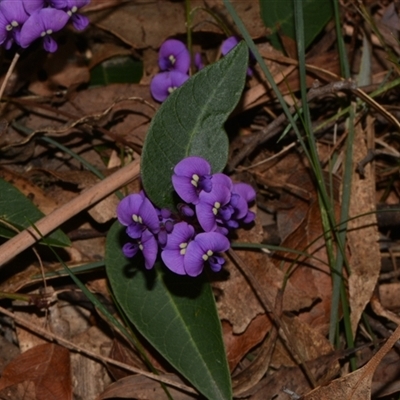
0;0;400;400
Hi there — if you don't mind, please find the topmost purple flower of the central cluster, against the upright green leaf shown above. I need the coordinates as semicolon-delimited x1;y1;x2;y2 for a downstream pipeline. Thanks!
172;156;212;204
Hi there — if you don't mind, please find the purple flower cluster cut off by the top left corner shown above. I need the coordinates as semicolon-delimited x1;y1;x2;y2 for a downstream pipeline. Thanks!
0;0;90;53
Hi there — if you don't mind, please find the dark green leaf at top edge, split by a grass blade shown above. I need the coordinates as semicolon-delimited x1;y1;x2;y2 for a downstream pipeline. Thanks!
260;0;333;49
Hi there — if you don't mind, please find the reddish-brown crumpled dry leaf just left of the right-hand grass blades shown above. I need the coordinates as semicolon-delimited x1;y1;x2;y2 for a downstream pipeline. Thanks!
273;168;339;334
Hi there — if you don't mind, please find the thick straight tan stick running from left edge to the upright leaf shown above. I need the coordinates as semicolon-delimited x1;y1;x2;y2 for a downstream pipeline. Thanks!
0;162;140;268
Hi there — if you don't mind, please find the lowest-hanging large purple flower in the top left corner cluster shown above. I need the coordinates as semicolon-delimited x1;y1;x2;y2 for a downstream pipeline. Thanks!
19;7;69;53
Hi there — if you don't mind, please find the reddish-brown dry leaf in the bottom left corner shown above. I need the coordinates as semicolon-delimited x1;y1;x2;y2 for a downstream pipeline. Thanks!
0;343;72;400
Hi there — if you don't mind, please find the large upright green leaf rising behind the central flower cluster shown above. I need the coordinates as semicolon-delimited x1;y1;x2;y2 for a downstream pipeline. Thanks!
141;43;248;209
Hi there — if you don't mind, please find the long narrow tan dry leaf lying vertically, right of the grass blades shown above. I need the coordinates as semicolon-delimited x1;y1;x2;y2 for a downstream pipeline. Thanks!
347;118;381;334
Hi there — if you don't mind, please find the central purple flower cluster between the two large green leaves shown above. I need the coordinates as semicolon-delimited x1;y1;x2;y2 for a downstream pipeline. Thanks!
117;156;256;276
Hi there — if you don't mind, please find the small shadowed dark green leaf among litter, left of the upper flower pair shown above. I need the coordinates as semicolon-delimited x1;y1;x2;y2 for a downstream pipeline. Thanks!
90;56;143;86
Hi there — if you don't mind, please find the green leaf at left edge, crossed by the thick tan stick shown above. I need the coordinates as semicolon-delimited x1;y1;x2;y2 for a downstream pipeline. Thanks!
0;179;71;247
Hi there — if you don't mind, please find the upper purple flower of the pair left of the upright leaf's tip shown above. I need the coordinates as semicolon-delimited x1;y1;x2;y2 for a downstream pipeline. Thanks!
158;39;190;74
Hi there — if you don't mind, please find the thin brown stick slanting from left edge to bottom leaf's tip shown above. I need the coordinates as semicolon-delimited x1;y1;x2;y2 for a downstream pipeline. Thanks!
0;307;197;393
